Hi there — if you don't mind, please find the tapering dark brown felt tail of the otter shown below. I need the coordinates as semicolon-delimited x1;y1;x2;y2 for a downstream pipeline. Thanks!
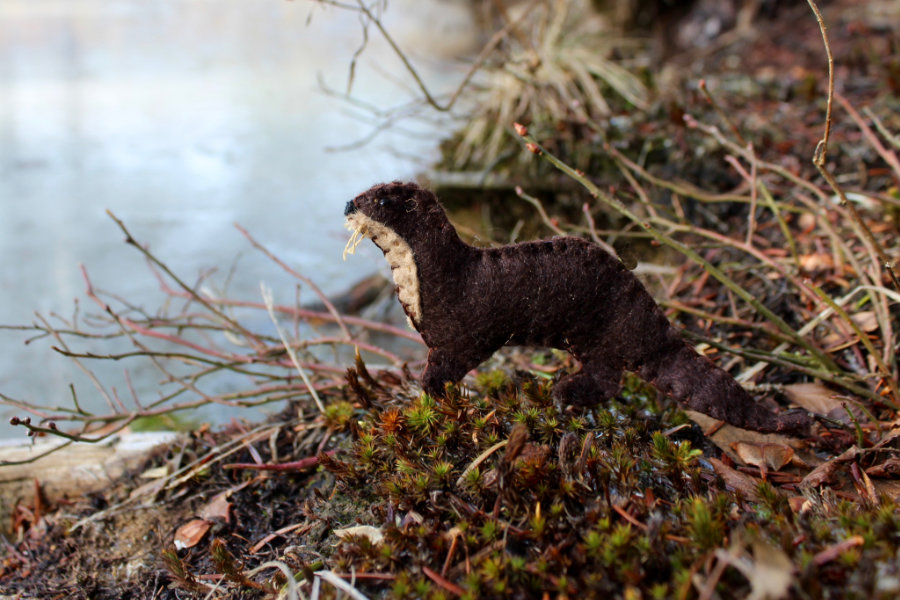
640;338;813;435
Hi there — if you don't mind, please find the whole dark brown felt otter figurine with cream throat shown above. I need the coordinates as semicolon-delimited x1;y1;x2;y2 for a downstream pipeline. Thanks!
344;182;812;433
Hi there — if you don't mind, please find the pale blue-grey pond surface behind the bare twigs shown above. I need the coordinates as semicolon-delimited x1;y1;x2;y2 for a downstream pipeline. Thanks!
0;0;474;435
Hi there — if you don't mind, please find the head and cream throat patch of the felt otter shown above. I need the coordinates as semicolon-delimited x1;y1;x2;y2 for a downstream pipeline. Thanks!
344;181;438;327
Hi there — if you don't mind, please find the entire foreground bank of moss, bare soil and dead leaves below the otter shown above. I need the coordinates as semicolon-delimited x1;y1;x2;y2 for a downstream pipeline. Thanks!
0;364;900;598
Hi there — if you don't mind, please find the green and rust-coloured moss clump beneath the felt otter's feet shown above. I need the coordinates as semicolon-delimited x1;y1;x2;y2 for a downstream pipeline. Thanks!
316;360;900;598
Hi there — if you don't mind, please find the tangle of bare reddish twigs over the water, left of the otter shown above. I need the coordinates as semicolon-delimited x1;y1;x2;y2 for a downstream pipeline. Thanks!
0;217;421;463
